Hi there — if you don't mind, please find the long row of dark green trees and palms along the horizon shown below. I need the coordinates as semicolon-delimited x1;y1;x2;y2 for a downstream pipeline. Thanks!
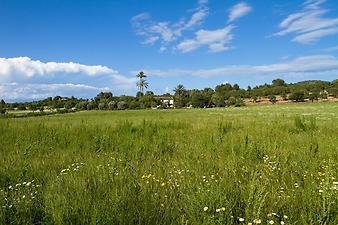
0;77;338;113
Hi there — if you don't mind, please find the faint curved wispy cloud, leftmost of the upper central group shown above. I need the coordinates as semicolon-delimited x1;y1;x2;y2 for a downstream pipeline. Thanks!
131;0;209;51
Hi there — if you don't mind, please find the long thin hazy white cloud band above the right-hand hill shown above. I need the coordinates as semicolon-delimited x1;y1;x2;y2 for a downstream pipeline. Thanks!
145;55;338;78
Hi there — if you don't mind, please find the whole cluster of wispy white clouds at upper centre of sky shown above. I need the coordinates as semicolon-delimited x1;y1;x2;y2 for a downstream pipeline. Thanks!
131;0;252;53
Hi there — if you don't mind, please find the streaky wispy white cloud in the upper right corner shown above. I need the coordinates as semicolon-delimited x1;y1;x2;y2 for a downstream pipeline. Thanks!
274;0;338;44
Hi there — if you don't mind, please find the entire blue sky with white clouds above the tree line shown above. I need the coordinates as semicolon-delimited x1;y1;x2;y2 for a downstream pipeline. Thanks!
0;0;338;101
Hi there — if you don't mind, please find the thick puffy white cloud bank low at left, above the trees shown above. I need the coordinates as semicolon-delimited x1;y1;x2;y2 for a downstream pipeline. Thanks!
0;57;135;100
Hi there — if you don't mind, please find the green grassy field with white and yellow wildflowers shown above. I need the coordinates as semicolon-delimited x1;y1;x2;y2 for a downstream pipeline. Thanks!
0;103;338;225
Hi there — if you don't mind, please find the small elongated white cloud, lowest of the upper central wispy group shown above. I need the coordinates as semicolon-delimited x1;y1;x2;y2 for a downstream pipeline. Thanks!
177;25;234;53
